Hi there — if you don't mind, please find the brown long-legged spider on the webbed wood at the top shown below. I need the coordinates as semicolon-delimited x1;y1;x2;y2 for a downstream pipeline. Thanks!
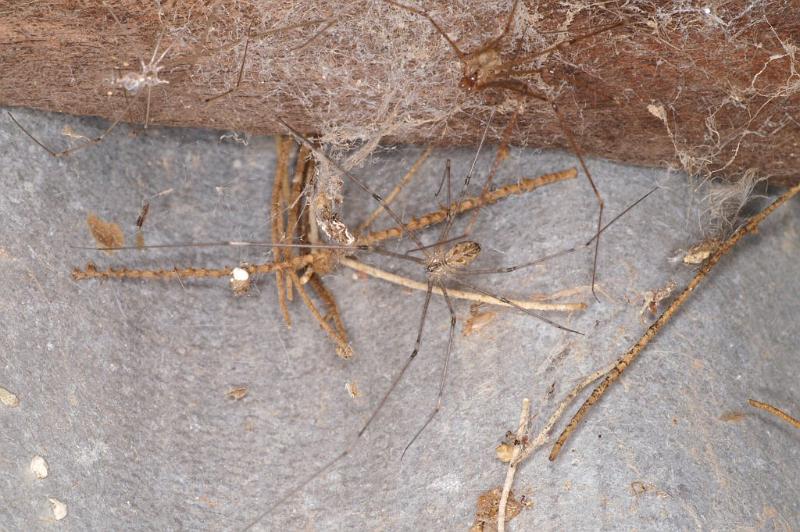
385;0;624;299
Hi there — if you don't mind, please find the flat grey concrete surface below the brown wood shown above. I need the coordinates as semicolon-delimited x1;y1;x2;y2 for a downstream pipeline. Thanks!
0;106;800;530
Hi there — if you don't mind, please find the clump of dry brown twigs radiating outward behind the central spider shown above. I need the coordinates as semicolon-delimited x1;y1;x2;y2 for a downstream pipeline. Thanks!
73;139;585;358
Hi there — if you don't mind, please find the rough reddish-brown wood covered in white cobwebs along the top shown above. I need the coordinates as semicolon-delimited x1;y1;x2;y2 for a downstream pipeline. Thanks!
0;0;800;181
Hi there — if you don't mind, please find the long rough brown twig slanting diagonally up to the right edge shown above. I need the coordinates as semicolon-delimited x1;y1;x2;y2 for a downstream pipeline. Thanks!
550;184;800;461
